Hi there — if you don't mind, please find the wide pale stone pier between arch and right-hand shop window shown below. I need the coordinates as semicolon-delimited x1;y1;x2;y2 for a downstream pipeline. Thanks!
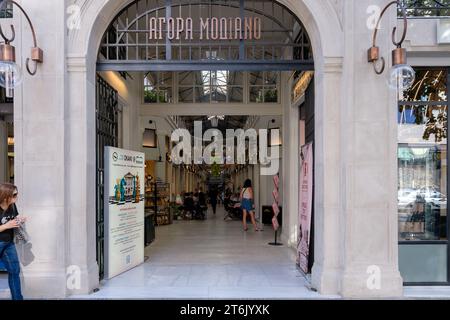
340;0;402;297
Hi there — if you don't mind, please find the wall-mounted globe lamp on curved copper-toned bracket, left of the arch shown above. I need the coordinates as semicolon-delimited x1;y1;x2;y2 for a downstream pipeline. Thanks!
0;0;44;98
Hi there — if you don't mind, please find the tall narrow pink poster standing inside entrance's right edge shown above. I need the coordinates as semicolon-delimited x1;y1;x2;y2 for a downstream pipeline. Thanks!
297;143;314;274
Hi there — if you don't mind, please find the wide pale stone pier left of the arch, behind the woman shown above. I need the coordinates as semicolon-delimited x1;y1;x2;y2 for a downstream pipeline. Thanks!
14;0;71;298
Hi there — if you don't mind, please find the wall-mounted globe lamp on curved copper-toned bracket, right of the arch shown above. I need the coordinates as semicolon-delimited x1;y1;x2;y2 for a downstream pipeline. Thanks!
368;1;416;92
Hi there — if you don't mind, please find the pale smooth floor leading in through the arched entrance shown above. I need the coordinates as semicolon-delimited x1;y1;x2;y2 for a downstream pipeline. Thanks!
71;207;330;299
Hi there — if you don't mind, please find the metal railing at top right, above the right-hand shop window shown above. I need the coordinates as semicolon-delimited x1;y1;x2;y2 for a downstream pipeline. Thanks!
399;0;450;18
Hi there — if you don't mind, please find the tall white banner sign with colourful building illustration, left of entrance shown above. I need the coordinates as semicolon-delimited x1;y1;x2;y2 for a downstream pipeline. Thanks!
104;147;145;279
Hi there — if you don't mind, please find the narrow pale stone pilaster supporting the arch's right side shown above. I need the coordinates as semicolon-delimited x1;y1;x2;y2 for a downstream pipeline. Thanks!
310;58;346;294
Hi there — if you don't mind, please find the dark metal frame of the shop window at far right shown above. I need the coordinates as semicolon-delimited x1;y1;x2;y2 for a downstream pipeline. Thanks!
397;66;450;287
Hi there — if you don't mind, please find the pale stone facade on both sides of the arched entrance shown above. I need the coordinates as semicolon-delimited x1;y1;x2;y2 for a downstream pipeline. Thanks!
11;0;446;298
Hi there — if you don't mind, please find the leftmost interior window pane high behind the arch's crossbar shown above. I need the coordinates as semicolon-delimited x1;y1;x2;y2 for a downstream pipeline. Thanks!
144;72;173;103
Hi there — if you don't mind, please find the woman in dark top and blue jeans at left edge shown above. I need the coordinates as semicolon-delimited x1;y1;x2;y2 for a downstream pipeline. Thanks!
0;183;26;300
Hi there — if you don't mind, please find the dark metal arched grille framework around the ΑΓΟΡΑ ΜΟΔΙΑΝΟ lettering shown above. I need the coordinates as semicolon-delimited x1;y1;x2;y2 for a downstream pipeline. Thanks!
97;0;314;72
